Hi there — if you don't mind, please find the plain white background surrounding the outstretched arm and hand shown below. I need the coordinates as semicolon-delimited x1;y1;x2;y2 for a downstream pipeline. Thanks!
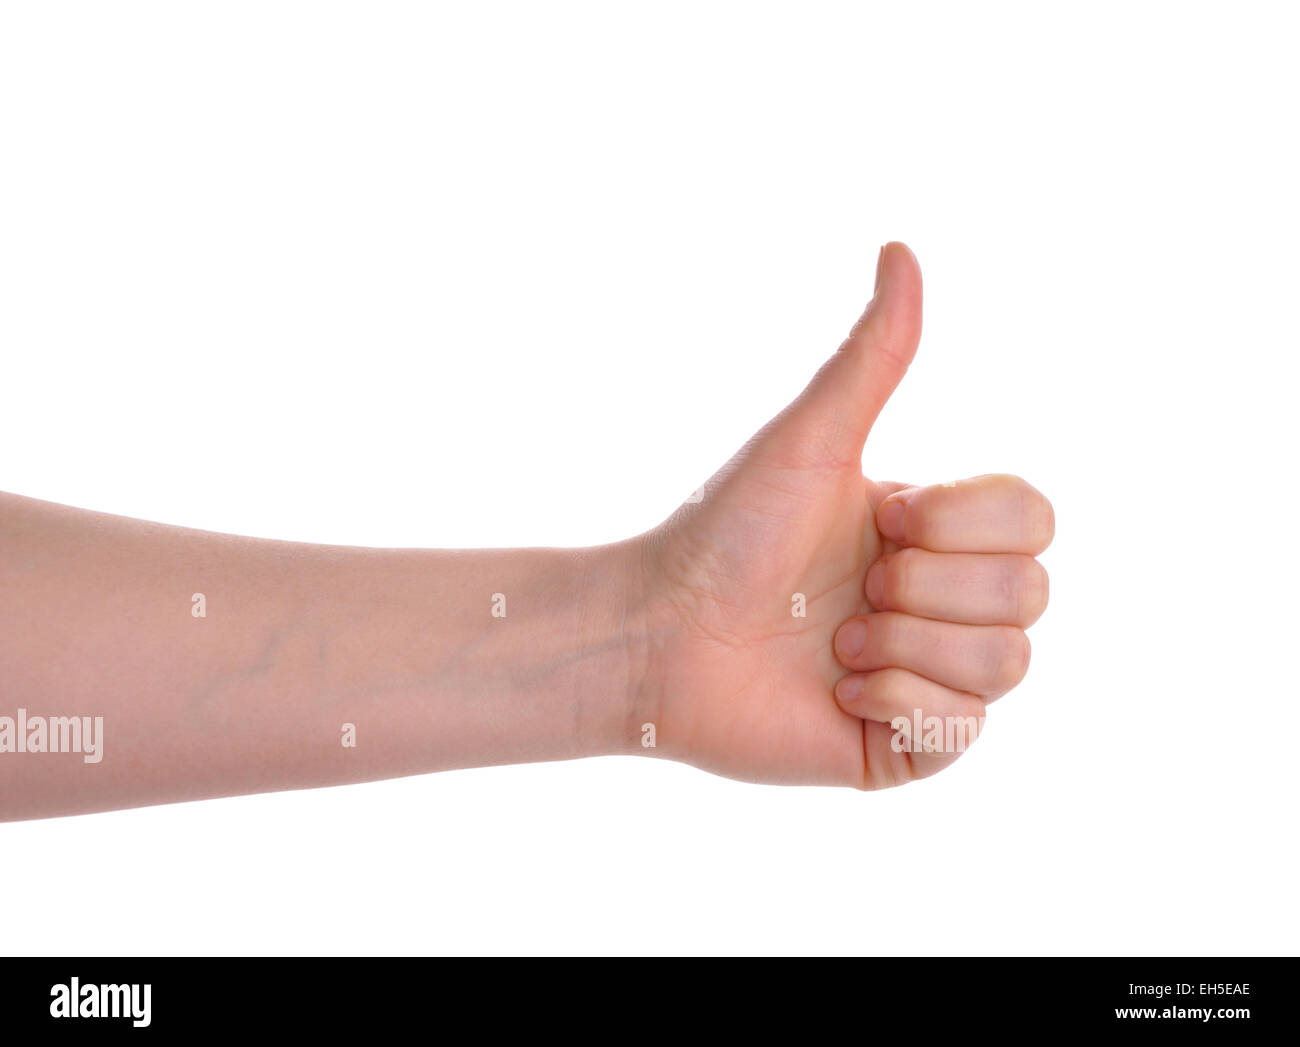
0;3;1300;953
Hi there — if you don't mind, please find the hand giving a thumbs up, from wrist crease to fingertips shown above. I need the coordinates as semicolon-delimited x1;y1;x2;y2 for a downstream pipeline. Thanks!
644;243;1053;788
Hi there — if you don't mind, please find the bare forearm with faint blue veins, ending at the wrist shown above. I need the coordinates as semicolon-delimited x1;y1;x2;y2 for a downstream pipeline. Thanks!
0;496;645;818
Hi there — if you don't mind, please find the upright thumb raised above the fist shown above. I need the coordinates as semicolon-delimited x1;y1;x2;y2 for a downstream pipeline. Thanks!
777;242;920;462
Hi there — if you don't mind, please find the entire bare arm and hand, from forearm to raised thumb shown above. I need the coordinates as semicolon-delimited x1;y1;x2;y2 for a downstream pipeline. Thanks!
0;243;1053;819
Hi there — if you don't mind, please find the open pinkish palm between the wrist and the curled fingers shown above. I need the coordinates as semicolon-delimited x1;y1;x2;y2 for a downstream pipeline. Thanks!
647;450;893;784
